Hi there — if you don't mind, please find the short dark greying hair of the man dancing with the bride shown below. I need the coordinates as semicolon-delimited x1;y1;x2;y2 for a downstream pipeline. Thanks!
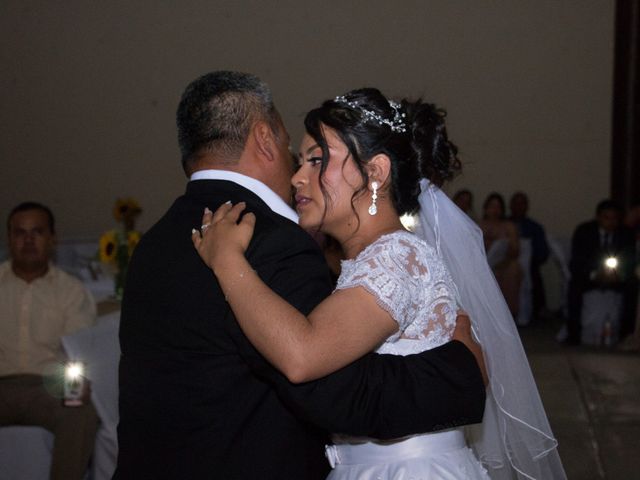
176;71;280;171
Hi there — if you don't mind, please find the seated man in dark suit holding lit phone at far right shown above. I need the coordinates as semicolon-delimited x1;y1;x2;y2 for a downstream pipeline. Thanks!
566;200;635;345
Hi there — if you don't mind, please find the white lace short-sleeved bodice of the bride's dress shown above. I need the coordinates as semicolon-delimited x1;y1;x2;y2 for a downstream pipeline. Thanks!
336;230;457;355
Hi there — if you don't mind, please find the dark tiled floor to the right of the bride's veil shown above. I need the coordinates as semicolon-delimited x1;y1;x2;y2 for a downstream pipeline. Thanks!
520;319;640;480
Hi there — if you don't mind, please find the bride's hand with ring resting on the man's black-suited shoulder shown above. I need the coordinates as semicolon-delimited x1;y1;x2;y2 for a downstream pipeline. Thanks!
191;202;256;272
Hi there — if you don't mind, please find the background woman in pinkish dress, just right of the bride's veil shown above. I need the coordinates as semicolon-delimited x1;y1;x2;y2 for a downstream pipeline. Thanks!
479;192;522;318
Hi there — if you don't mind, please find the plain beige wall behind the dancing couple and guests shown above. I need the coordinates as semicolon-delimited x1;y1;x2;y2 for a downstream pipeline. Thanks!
0;0;614;246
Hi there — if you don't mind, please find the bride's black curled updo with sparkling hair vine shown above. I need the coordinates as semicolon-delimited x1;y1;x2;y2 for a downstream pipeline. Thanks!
304;88;461;215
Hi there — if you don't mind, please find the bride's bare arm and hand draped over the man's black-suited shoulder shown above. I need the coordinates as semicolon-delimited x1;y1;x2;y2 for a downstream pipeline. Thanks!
193;204;398;383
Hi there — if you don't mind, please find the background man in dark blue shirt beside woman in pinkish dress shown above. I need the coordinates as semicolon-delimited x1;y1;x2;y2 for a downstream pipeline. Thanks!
509;192;549;318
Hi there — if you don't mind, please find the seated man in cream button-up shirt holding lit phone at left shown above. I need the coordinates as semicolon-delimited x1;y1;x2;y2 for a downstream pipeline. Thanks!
0;202;98;480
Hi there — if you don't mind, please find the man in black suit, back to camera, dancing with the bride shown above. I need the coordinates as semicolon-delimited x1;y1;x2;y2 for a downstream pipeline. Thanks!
114;72;485;480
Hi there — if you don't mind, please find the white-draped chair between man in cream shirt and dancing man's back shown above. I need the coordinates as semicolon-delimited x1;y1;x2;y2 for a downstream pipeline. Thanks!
62;311;120;480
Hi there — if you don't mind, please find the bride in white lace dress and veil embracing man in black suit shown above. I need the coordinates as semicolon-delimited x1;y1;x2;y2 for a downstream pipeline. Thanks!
193;89;564;480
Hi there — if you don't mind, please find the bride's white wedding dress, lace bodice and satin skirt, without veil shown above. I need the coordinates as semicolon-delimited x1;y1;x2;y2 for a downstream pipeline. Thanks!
326;231;489;480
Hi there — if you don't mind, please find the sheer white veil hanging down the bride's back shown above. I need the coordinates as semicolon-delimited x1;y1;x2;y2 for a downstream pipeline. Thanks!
415;179;566;480
